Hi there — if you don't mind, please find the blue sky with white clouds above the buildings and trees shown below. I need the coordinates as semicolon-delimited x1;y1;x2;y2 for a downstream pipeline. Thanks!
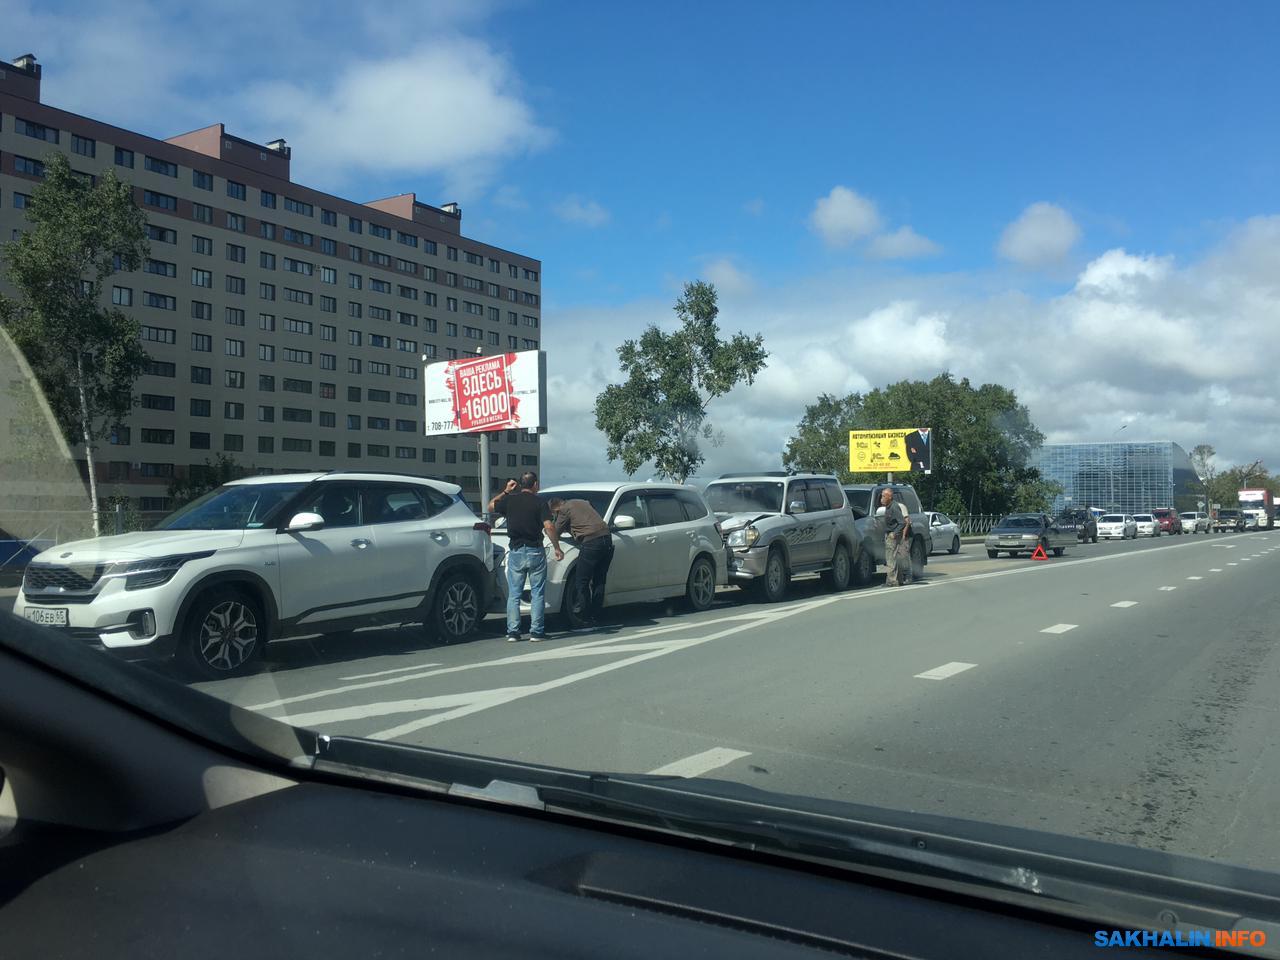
0;0;1280;475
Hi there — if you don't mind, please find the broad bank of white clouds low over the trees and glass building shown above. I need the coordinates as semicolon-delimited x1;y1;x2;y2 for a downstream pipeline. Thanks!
543;216;1280;480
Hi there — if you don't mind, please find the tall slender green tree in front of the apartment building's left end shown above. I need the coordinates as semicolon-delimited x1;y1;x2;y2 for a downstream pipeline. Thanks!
0;154;148;535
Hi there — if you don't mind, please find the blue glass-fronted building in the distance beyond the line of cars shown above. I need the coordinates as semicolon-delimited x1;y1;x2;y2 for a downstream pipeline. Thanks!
1032;440;1199;513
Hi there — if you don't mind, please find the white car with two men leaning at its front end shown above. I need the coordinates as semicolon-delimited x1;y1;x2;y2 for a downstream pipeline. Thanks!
493;483;728;627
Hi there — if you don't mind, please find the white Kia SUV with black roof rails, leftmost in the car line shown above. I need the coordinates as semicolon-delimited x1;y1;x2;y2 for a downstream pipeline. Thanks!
14;472;493;678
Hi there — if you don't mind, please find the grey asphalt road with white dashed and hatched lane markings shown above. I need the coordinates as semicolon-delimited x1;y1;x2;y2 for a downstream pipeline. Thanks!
183;531;1280;870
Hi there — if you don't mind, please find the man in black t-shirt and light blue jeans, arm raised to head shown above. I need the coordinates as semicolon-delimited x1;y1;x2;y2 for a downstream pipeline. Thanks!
489;470;564;643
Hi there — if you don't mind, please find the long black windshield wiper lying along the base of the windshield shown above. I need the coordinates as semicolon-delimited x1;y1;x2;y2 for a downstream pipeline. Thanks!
315;736;1280;955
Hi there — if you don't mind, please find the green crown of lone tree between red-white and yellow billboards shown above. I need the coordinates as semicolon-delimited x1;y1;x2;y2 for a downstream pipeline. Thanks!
595;280;769;483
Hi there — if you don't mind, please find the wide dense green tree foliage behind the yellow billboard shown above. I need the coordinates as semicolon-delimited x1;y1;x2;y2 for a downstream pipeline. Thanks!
782;374;1061;513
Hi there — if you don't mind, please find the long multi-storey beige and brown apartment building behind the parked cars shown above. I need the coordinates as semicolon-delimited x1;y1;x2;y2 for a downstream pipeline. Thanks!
0;54;541;511
